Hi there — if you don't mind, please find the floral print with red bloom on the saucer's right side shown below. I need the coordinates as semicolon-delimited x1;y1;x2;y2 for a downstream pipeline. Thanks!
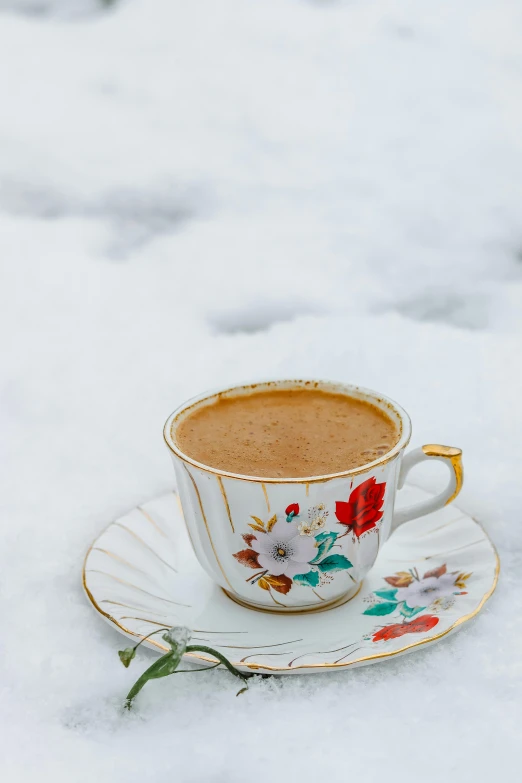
363;563;471;624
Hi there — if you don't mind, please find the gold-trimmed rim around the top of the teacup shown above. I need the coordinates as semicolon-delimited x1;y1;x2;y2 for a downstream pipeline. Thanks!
163;378;411;484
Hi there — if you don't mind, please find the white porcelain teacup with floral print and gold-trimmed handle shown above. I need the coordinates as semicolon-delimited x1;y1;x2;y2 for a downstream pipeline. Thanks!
164;380;463;612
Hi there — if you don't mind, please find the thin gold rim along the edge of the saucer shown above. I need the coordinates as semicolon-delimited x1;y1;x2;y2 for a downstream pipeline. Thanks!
82;502;500;674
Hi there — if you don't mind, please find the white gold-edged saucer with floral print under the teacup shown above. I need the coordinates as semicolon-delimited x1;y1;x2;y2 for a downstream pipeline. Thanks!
83;485;500;674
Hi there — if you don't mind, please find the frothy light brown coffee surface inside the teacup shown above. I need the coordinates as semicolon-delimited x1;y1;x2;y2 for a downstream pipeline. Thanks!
172;388;399;478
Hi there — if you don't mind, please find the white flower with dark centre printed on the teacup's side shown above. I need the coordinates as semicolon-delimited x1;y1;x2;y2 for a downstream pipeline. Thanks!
250;519;317;579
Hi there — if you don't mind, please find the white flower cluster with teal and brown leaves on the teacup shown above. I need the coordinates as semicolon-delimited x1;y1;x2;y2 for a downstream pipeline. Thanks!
234;503;352;600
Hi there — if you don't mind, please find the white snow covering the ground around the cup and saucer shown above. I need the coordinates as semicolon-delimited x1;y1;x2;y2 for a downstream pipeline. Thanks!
0;0;522;783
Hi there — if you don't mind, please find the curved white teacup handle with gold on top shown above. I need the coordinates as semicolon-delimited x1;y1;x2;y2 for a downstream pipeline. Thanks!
391;443;464;533
